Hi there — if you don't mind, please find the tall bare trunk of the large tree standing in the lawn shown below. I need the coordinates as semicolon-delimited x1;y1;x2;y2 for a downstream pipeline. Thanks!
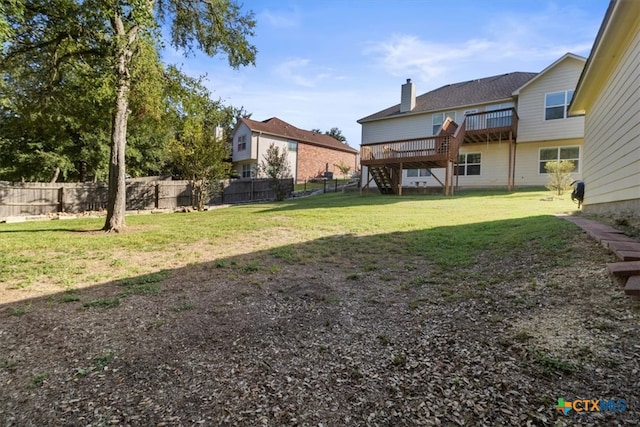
102;10;138;233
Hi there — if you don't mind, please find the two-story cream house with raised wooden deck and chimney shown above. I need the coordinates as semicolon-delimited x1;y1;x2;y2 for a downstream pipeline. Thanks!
358;53;586;194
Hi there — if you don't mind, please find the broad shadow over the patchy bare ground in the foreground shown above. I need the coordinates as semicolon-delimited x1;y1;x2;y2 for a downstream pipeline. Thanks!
0;216;640;425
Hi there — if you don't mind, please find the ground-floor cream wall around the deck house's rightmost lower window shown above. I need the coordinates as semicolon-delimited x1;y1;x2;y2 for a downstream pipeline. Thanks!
514;138;584;186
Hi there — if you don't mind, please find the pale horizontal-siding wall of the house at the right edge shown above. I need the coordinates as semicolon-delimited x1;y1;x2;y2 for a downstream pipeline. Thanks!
584;29;640;211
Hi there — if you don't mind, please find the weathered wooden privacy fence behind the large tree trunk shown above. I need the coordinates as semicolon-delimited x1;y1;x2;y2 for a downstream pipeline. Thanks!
0;179;293;218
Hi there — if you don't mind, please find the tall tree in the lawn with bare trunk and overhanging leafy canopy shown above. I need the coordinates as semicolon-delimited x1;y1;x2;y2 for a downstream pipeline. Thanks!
0;0;256;232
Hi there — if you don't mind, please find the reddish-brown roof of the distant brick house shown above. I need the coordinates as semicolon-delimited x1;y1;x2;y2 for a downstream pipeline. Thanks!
240;117;359;153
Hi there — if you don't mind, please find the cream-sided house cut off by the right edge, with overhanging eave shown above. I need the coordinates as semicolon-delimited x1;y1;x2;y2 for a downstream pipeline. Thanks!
569;0;640;217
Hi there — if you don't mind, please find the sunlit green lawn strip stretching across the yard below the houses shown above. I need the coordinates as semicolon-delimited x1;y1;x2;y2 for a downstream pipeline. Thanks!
0;191;575;300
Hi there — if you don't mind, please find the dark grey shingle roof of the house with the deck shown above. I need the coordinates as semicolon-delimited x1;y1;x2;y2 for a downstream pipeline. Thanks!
358;72;538;123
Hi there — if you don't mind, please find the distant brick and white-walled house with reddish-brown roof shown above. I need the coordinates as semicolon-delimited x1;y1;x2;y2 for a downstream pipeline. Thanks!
232;117;358;182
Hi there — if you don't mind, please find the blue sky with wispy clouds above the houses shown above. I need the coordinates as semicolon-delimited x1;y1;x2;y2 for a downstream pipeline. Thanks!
163;0;609;148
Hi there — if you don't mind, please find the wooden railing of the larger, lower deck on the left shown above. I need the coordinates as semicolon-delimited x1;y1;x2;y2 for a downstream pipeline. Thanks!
360;135;454;162
